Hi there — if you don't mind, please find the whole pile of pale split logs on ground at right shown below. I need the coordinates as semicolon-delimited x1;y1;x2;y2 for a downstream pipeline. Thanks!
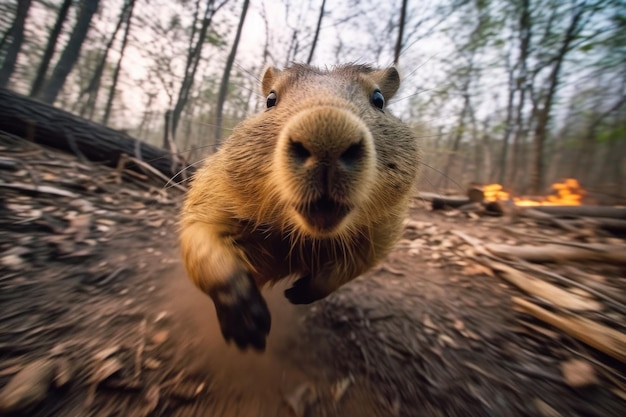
453;231;626;363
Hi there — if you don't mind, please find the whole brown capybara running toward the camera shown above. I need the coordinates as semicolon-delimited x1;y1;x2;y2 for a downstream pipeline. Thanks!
180;65;419;350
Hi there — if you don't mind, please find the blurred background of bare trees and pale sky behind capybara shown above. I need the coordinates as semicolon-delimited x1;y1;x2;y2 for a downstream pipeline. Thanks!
0;0;626;202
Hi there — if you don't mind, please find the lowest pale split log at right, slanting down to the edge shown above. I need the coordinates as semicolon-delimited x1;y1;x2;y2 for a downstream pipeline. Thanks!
513;297;626;363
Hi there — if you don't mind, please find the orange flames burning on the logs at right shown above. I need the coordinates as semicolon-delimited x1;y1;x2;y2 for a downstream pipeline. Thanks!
483;178;585;206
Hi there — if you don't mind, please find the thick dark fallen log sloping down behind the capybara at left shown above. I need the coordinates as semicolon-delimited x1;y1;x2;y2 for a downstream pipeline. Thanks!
0;88;191;178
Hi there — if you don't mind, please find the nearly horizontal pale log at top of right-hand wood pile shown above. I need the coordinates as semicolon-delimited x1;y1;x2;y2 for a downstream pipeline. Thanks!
485;243;626;265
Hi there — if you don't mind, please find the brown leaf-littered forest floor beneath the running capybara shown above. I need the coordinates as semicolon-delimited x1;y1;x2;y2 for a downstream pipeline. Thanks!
0;131;626;417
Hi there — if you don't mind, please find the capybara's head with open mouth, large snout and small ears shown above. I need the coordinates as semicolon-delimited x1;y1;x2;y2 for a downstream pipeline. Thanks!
262;65;418;238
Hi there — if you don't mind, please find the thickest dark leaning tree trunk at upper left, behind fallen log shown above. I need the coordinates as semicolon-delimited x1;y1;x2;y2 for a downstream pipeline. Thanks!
41;0;99;104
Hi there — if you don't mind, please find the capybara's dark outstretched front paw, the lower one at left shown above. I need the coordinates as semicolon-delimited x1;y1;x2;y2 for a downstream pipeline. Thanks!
210;274;272;351
